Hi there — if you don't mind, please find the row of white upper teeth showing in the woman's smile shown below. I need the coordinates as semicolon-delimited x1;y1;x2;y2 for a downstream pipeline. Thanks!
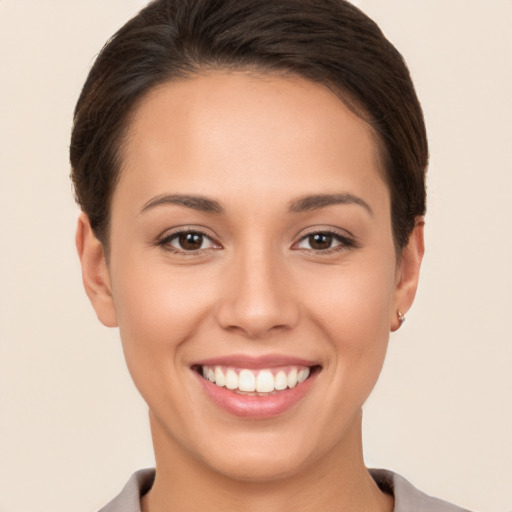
202;366;310;394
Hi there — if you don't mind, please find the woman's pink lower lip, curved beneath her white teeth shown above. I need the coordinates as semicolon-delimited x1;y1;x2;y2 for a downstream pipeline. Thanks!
195;372;316;419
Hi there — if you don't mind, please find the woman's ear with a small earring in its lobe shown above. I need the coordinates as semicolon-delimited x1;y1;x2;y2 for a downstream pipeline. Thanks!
390;217;425;331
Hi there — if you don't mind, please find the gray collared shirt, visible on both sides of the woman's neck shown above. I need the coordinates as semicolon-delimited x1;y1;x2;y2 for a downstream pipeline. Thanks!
99;469;469;512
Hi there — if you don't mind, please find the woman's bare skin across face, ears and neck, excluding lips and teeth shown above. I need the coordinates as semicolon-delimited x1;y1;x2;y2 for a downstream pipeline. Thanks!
77;72;423;512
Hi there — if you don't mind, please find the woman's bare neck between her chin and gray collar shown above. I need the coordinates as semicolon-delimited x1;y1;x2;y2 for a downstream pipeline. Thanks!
142;415;393;512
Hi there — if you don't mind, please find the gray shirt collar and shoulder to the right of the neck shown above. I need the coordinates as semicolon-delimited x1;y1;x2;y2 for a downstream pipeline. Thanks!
370;469;469;512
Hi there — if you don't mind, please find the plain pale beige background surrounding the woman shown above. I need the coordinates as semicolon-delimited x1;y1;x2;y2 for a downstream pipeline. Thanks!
0;0;512;512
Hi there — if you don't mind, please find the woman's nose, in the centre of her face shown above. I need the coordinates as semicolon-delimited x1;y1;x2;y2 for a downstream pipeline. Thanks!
216;246;300;339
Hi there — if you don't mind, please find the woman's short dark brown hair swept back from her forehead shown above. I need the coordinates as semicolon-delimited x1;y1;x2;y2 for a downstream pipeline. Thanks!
70;0;428;249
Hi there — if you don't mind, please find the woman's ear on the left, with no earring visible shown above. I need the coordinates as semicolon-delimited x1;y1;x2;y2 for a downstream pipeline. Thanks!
75;213;117;327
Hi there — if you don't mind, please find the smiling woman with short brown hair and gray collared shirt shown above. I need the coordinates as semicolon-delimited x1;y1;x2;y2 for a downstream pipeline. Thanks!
71;0;472;512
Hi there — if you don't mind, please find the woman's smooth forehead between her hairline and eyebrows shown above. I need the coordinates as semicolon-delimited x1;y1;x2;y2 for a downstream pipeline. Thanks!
114;72;387;213
